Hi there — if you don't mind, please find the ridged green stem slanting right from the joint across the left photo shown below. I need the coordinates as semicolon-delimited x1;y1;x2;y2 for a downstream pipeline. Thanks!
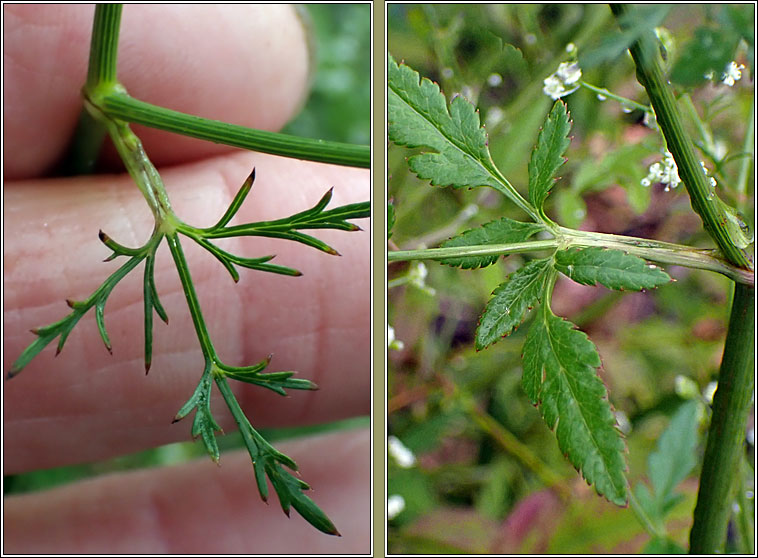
96;90;371;168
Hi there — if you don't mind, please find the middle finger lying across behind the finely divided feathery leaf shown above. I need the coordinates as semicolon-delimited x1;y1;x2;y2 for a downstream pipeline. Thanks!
3;153;371;474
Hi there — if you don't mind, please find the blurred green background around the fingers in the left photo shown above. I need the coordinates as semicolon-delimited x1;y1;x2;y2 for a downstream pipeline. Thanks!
3;4;371;500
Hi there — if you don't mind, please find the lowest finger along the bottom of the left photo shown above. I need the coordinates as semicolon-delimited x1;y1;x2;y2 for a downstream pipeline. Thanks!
3;429;371;555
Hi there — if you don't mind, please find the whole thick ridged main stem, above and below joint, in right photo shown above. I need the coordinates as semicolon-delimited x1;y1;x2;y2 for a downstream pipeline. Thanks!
610;4;755;554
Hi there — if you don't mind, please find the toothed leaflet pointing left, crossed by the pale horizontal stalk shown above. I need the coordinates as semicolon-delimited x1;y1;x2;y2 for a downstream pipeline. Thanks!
441;217;545;269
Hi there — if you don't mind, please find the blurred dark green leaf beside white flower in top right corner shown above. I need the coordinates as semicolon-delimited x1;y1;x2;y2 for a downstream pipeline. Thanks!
671;27;740;86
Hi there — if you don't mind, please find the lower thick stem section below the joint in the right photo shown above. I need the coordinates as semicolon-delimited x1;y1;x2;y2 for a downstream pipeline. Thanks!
690;285;755;554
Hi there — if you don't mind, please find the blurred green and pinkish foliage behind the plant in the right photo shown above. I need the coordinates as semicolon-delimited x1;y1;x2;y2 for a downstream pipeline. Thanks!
387;4;755;554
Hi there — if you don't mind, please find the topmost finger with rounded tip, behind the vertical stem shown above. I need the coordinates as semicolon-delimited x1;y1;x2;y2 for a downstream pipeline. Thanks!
3;4;309;179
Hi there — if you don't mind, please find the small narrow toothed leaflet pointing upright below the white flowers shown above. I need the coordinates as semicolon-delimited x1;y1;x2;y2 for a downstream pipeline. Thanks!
529;100;571;214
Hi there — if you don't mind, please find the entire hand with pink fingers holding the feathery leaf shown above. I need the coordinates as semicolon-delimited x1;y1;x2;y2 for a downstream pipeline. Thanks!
3;5;370;554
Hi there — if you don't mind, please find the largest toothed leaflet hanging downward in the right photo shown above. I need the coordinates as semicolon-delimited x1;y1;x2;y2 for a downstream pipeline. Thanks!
522;306;627;505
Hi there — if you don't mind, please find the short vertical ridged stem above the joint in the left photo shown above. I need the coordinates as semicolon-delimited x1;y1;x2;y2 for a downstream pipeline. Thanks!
85;4;123;89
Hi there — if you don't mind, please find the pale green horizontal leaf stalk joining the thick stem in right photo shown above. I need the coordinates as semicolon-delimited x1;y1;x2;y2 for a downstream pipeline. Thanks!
387;235;755;285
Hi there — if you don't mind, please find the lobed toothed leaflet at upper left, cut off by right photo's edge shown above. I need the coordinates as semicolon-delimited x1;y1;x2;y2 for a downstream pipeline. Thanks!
387;55;502;195
